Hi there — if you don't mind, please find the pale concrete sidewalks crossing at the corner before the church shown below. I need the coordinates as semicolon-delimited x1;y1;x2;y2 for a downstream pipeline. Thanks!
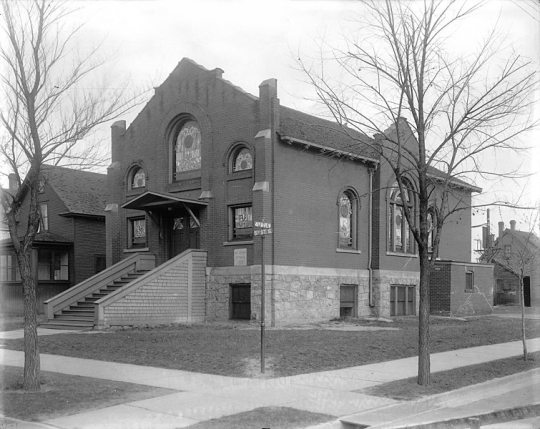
0;329;540;429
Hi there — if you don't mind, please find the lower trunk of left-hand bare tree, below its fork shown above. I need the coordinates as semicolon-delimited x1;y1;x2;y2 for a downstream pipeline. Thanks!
21;254;40;391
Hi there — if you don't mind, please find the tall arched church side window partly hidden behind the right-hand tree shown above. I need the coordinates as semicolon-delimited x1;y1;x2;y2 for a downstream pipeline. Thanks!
388;179;414;253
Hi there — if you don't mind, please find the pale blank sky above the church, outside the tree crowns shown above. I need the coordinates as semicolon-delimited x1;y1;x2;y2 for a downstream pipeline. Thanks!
2;0;540;258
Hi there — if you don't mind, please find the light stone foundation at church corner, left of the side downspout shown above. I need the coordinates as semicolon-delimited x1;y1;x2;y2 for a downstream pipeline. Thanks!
206;266;371;325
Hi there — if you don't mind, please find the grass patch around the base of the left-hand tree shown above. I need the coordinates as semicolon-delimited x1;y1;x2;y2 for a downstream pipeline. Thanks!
0;365;178;427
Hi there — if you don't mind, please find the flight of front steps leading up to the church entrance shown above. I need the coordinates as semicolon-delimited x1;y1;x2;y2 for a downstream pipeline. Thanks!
39;270;149;330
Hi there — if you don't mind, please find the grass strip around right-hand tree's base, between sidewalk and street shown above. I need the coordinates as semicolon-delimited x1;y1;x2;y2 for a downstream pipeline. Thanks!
357;352;540;401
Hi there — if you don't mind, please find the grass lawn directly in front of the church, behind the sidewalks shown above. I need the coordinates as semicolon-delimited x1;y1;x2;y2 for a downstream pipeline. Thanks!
1;317;540;376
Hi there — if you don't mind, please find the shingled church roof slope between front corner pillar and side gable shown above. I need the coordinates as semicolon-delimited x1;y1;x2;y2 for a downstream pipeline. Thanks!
278;106;379;162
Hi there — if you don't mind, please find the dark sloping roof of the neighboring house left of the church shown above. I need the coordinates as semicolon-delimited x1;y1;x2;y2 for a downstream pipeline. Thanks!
43;165;107;216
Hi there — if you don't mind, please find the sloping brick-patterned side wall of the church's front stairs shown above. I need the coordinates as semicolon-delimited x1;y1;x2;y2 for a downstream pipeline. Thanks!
99;247;206;326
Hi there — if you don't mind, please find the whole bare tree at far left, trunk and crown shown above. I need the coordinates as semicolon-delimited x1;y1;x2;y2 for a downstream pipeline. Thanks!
0;0;147;390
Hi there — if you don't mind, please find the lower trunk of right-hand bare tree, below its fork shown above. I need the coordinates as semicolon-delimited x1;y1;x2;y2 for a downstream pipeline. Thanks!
418;251;431;386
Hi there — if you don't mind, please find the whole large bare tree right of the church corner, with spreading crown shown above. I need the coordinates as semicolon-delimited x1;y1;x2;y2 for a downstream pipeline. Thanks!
298;0;538;385
